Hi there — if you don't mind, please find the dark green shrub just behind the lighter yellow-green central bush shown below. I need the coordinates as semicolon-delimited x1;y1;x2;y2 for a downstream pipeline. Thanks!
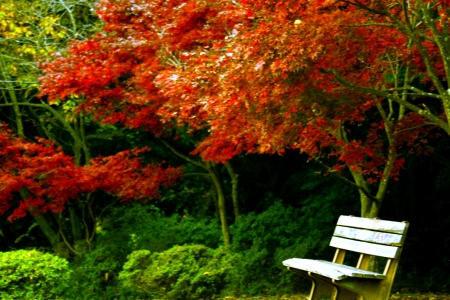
98;203;221;255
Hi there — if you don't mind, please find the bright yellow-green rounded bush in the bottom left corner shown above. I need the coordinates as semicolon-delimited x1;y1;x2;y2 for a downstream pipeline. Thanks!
0;250;70;300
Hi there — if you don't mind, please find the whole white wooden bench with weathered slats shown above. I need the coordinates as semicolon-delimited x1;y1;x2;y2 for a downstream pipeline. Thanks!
283;216;409;300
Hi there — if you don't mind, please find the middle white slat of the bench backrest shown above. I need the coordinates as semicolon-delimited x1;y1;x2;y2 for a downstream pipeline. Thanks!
333;226;403;246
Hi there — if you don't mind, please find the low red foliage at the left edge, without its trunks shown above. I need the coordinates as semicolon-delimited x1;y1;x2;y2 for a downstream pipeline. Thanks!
0;124;182;221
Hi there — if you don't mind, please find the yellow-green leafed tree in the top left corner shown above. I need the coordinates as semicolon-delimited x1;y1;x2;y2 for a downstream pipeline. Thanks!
0;0;103;169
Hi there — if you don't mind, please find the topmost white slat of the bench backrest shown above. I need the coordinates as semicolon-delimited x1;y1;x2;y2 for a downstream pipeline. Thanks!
337;216;408;234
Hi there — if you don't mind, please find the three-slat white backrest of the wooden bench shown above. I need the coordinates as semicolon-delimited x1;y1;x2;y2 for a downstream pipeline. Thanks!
330;216;409;259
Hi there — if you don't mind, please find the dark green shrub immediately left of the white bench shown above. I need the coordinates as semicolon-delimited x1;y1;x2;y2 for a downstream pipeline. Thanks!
228;202;312;295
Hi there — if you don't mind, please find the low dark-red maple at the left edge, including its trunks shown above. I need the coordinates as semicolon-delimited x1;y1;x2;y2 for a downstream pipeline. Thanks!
0;124;182;255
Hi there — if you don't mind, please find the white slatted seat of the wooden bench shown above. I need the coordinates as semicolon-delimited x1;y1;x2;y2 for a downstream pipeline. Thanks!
283;258;386;280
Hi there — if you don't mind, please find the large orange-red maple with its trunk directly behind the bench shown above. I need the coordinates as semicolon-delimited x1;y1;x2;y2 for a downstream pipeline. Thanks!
118;1;448;217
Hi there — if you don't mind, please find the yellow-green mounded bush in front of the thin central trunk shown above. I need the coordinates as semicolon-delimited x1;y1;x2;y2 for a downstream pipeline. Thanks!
119;245;239;299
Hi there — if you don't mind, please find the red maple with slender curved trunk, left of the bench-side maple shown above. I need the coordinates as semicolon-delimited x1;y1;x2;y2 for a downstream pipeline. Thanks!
41;1;251;245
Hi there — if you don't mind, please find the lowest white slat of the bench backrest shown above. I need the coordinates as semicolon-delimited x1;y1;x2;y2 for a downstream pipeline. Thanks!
330;236;399;258
